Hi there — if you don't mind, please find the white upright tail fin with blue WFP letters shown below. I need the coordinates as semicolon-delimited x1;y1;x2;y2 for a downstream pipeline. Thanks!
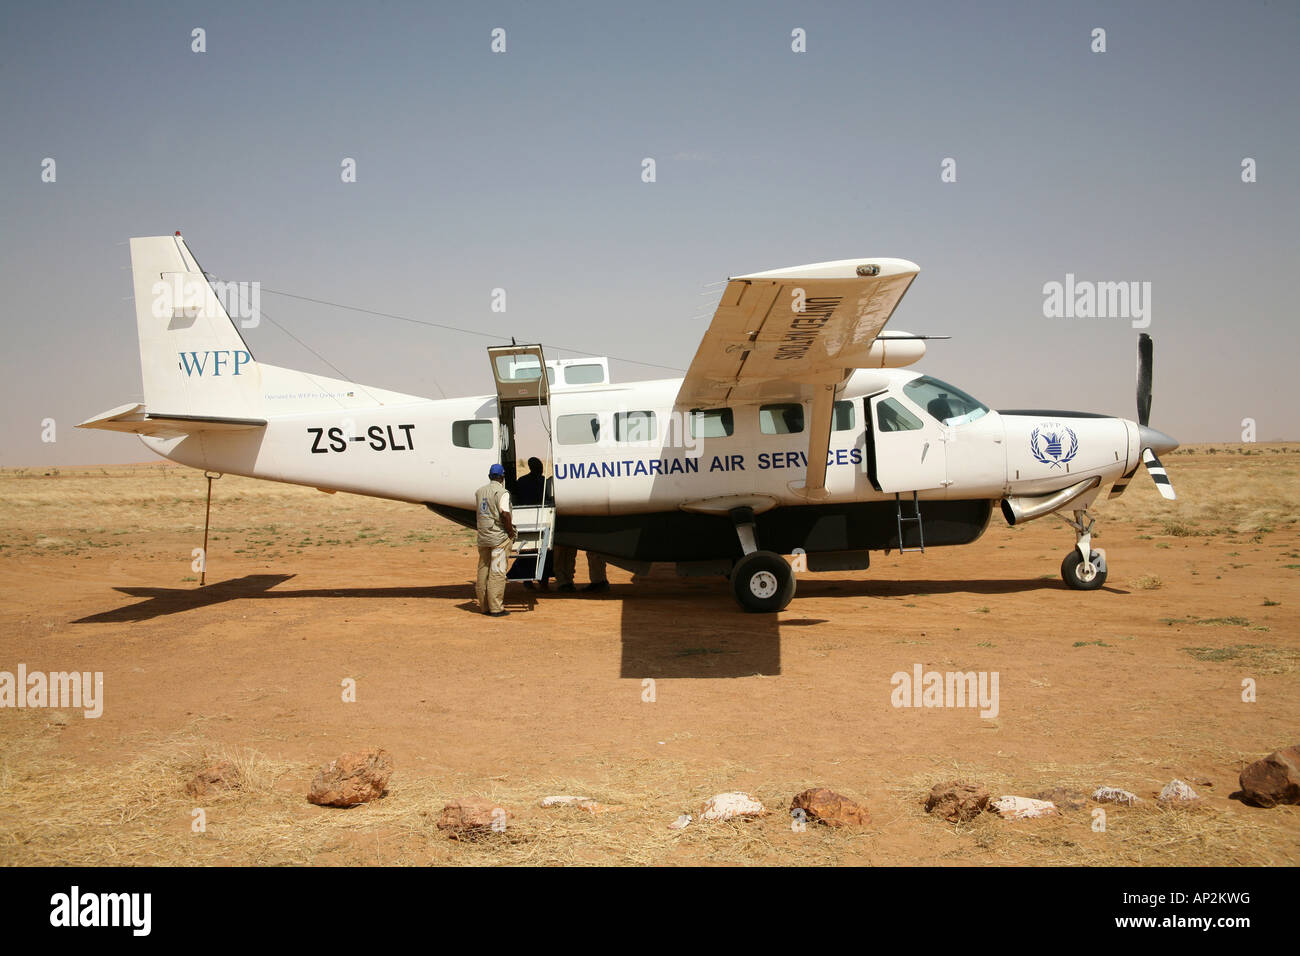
131;233;263;419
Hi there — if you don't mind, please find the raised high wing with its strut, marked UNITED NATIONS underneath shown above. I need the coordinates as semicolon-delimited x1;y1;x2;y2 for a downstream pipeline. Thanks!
676;259;920;493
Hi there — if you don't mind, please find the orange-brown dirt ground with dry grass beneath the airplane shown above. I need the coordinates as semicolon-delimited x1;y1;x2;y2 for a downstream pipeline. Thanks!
0;445;1300;865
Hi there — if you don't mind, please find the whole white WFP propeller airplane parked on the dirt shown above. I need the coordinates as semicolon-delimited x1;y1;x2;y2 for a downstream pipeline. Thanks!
81;233;1178;611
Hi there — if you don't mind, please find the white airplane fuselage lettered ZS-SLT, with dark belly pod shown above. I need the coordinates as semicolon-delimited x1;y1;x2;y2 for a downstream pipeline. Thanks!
142;367;1139;562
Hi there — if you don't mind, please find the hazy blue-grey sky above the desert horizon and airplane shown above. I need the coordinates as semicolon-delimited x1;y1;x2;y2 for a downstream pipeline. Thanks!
0;0;1300;466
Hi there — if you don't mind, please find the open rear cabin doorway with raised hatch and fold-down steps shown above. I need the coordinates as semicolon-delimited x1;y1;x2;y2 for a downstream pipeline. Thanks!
488;345;555;580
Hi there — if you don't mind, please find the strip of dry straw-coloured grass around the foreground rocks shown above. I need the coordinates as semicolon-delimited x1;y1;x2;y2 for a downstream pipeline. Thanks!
0;711;1300;866
